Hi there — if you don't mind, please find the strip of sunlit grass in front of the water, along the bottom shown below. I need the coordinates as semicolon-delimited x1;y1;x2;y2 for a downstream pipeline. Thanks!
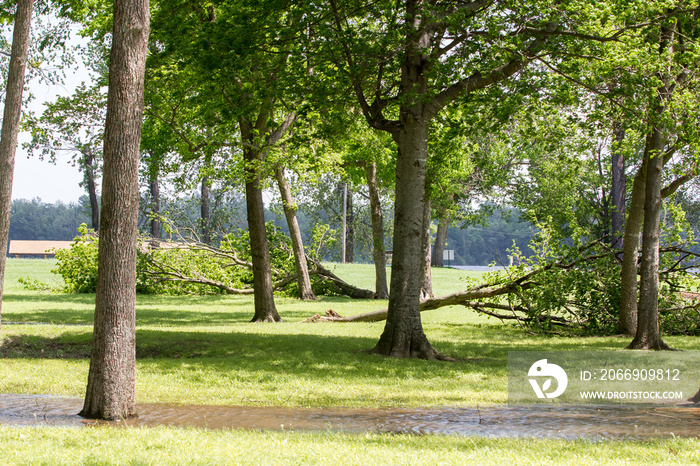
0;427;700;465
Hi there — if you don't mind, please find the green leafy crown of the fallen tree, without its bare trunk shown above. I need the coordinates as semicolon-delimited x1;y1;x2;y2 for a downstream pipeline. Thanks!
462;225;700;335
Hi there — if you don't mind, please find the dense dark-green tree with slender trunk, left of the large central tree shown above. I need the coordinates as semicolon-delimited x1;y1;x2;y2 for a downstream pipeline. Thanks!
153;1;322;321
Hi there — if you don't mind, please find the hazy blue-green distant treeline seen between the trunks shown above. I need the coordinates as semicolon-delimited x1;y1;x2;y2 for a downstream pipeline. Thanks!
10;196;533;265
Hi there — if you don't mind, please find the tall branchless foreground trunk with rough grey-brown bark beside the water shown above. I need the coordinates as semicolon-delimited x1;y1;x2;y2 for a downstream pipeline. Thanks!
80;0;150;420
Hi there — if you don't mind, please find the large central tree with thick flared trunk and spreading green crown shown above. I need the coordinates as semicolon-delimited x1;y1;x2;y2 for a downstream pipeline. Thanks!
317;0;644;359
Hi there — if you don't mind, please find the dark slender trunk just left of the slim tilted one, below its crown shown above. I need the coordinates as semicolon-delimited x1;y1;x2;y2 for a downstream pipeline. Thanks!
243;149;282;322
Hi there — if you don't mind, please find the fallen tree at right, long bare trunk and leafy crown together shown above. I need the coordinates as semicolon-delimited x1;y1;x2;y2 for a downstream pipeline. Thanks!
304;241;700;334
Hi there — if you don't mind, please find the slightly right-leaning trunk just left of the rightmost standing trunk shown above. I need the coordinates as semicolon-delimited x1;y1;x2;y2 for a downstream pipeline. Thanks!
618;158;647;336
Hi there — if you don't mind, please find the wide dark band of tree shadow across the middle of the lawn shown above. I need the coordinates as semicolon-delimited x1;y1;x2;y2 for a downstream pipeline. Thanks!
0;324;628;372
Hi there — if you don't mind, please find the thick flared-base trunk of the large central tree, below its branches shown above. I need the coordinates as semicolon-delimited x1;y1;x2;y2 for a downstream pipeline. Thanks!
370;117;447;359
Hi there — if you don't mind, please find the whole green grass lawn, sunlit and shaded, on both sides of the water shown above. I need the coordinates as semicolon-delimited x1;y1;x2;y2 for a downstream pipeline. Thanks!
0;259;700;464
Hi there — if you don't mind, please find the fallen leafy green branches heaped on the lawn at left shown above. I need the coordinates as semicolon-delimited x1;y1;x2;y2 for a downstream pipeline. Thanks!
48;222;374;298
